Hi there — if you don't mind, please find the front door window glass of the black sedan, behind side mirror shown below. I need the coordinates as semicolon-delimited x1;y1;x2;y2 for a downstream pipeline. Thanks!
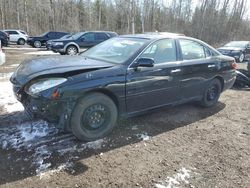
141;39;177;64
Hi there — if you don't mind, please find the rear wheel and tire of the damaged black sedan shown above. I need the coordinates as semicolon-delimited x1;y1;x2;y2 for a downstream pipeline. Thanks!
200;79;222;107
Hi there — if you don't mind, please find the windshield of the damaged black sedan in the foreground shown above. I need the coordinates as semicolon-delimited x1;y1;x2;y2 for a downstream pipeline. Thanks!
81;38;148;64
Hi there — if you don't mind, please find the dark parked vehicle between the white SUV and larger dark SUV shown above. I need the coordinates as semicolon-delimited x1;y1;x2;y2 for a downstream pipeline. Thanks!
27;31;69;48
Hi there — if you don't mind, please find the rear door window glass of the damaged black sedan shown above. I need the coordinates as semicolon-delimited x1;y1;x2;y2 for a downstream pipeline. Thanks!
180;39;206;60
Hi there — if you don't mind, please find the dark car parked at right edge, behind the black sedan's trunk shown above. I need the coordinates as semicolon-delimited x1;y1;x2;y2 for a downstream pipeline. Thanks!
218;41;250;63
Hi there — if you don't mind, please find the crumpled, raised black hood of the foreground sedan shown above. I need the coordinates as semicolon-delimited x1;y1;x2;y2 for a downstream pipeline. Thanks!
10;56;114;85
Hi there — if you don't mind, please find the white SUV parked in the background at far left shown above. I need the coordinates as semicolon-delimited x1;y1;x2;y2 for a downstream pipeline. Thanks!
4;29;29;45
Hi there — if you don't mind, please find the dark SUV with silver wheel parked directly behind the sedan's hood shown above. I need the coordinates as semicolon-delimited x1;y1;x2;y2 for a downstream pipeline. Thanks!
51;31;117;55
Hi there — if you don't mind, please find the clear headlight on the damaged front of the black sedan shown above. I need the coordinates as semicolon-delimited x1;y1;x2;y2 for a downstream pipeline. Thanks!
28;78;67;94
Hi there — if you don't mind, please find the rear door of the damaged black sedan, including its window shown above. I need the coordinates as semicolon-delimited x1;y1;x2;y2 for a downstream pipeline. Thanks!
178;39;220;100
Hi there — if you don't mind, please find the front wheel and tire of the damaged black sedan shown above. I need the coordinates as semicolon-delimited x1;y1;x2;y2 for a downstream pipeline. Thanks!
71;93;118;141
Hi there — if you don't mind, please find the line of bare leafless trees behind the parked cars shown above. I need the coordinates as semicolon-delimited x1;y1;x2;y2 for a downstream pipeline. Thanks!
0;0;250;45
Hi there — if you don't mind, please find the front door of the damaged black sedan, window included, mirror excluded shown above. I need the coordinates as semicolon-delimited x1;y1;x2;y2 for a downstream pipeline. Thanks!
126;39;181;113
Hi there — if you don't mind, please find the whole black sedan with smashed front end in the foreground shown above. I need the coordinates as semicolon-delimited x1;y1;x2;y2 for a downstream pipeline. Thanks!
11;35;236;141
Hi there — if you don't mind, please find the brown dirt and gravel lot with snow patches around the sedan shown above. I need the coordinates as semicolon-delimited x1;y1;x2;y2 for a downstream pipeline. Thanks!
0;48;250;188
